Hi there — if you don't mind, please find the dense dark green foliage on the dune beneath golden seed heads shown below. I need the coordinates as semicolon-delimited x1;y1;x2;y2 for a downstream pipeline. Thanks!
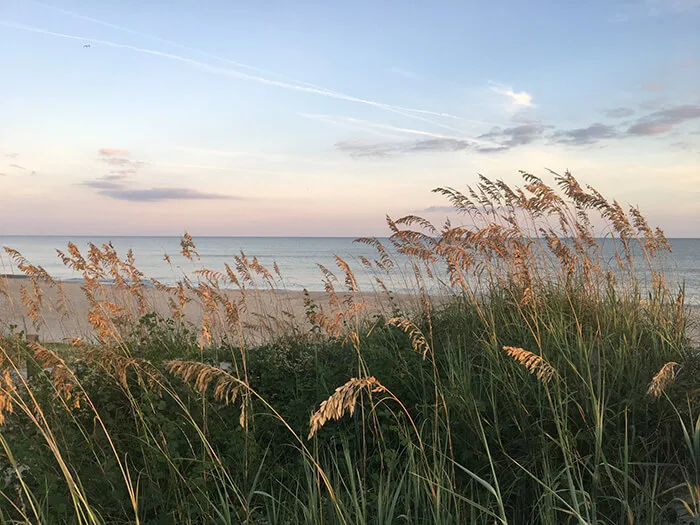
0;288;700;523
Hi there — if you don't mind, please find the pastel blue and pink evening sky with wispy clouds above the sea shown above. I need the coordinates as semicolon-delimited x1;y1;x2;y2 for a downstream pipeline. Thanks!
0;0;700;237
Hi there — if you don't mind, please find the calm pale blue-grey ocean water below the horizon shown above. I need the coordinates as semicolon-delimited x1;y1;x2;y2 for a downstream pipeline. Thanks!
0;236;700;306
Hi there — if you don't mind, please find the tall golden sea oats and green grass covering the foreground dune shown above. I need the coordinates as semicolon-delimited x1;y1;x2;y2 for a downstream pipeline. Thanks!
0;173;700;524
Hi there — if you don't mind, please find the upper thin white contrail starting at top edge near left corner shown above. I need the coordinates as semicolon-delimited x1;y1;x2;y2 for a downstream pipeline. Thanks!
10;0;464;124
